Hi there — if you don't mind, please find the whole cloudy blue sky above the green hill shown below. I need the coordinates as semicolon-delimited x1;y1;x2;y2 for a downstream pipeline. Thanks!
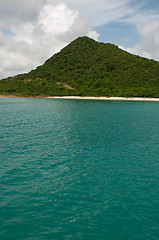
0;0;159;79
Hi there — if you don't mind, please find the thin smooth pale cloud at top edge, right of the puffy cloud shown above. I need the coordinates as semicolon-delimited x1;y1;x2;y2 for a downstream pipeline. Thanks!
48;0;134;27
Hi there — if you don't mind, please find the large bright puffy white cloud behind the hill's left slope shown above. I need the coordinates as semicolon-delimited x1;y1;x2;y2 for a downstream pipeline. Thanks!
0;4;98;78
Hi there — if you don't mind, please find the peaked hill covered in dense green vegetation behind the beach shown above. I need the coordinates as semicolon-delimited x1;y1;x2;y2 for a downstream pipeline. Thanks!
0;37;159;97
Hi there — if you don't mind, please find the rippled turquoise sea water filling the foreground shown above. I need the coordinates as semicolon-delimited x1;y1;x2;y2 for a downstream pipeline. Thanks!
0;98;159;240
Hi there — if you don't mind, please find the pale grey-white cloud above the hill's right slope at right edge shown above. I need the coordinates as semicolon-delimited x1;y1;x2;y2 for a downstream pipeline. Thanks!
122;21;159;61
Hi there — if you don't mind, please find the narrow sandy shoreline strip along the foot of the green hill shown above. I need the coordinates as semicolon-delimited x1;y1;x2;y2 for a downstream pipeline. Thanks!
0;95;159;102
